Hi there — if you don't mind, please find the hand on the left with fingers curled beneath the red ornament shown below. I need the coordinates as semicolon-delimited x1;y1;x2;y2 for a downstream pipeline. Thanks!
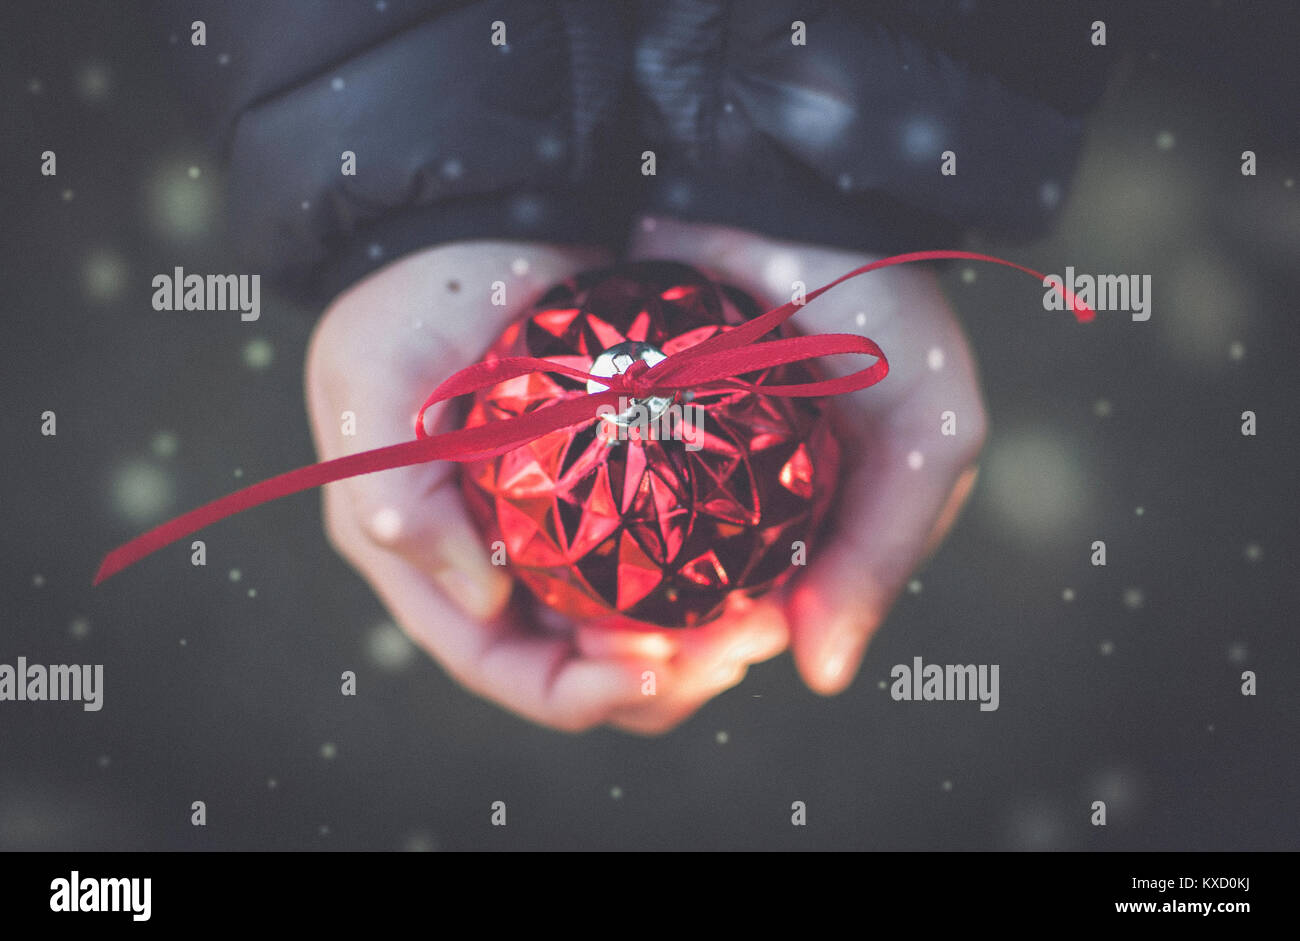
307;242;788;733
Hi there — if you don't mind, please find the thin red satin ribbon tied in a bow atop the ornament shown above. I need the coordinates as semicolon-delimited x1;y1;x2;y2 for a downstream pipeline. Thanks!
94;251;1095;585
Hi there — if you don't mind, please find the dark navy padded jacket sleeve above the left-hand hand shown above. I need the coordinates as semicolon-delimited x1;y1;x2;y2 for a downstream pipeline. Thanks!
159;0;631;300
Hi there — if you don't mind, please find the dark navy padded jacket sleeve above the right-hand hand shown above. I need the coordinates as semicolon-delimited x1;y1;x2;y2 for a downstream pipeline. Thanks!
634;0;1112;253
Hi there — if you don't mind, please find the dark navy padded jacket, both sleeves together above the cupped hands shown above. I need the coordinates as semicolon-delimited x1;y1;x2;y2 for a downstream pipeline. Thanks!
160;0;1295;299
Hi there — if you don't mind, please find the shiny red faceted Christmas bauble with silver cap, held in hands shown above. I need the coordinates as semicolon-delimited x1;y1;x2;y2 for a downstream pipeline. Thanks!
463;263;840;628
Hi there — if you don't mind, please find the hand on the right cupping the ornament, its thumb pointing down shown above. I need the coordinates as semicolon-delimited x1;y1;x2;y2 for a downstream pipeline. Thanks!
631;218;985;694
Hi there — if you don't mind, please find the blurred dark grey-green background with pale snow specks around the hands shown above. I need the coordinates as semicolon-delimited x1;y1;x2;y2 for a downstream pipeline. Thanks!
0;4;1300;850
